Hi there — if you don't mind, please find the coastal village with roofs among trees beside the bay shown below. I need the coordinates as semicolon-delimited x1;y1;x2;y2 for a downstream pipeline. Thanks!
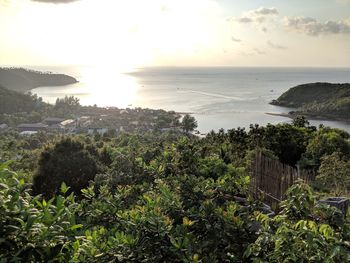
0;108;185;136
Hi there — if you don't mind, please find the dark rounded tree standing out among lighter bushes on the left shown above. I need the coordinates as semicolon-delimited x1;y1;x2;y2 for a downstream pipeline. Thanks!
33;138;99;196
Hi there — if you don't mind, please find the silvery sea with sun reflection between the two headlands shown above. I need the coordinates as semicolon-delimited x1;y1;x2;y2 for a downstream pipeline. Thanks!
32;67;350;133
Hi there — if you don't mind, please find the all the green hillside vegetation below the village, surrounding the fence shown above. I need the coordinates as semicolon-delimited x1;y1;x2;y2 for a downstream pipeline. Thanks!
0;115;350;263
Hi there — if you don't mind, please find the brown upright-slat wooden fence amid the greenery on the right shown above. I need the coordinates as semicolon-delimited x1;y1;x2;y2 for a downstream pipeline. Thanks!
251;151;315;205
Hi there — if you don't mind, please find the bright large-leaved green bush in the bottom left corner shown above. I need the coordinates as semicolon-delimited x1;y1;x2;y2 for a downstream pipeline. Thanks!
0;165;82;262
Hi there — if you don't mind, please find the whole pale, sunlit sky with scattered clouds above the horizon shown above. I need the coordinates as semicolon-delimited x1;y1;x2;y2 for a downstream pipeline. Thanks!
0;0;350;67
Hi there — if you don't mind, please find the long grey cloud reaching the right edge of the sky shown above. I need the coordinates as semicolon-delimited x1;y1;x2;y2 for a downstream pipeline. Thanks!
284;17;350;36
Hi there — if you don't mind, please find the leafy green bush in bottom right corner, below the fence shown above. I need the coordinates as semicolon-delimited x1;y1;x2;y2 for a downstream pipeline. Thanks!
245;184;350;263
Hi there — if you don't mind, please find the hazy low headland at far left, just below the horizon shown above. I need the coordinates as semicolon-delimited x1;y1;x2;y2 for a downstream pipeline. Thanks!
0;68;78;92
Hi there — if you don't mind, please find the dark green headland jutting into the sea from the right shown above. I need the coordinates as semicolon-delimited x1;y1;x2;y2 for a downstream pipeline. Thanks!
271;83;350;120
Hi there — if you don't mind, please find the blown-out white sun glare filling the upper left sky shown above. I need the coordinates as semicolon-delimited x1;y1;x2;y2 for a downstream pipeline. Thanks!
0;0;220;67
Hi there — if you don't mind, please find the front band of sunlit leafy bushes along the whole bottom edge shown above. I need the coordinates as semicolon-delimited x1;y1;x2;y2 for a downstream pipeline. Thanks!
0;166;350;262
